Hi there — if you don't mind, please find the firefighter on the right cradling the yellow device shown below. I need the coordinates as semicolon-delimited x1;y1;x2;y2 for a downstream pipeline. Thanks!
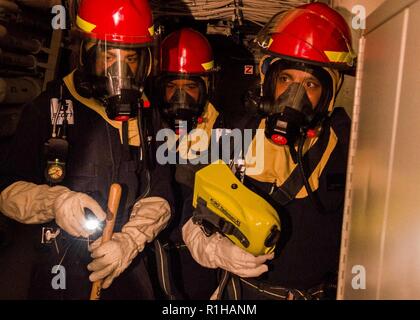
183;3;355;300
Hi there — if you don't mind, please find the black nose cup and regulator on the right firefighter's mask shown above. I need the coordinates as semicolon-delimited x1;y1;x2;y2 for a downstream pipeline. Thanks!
261;83;317;146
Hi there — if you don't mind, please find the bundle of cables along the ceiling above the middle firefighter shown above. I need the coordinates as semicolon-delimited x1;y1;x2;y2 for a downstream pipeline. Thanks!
150;0;310;25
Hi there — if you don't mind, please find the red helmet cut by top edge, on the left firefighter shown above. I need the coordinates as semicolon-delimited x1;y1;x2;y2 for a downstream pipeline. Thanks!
76;0;154;45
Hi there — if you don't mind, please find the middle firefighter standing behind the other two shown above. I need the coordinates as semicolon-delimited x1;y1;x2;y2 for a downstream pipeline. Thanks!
157;28;224;300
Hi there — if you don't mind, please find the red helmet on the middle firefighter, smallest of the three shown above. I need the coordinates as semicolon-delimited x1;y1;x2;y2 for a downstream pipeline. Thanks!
161;28;214;74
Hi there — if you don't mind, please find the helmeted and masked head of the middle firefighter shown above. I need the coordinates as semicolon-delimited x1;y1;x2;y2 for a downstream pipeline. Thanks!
159;28;218;133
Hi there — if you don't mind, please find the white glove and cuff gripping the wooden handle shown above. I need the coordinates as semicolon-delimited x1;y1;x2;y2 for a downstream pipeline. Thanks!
87;197;171;289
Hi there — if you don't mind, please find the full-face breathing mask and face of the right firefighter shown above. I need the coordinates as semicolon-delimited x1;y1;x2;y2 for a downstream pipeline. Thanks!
258;59;333;163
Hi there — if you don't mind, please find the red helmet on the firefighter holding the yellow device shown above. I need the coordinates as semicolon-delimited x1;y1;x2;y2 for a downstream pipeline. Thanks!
257;3;356;70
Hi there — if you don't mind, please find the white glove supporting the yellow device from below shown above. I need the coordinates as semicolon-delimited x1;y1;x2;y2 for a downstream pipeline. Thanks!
182;219;274;278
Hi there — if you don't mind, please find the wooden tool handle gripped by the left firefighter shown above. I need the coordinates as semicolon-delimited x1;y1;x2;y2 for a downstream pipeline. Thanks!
90;183;121;300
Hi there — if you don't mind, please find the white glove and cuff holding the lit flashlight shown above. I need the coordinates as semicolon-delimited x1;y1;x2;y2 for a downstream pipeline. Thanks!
0;181;106;237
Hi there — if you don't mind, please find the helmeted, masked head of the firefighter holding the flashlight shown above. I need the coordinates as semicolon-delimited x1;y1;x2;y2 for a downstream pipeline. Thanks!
75;1;154;120
